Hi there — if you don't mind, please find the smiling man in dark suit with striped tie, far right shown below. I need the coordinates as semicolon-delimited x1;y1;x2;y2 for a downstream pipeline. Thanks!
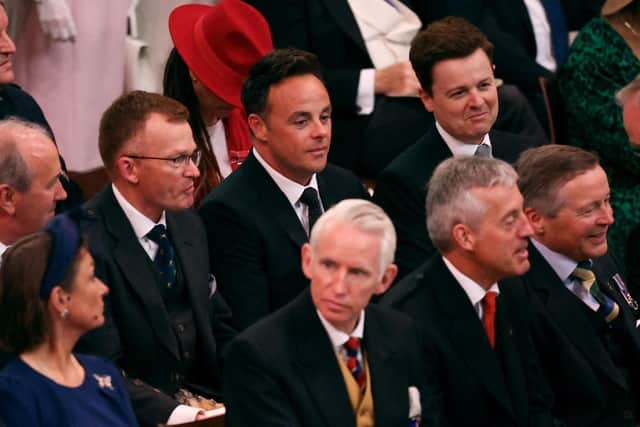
516;145;640;427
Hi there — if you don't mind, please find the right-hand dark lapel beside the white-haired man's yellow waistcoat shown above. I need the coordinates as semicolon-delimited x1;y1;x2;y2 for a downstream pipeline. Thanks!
364;311;402;426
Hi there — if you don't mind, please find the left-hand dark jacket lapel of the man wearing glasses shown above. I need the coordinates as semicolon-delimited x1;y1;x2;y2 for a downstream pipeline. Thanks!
99;185;179;358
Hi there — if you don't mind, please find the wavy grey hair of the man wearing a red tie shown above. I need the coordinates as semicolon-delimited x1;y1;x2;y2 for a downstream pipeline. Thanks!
426;156;518;253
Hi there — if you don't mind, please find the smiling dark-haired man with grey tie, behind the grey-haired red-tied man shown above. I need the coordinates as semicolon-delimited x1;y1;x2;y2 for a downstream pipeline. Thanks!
374;18;537;277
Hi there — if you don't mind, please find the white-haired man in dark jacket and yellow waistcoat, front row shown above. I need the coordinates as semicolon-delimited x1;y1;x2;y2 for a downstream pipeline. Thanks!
225;199;422;427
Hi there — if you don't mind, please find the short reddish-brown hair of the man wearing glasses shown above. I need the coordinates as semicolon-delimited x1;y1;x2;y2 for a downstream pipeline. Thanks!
98;90;189;172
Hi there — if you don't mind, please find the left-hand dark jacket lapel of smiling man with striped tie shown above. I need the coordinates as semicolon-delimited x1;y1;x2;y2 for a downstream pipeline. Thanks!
526;244;629;390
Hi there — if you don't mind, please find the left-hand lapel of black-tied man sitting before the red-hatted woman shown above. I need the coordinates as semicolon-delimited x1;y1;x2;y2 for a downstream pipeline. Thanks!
244;151;308;248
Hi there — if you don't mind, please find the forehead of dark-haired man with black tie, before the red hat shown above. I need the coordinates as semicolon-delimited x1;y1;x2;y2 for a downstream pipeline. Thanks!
267;74;329;114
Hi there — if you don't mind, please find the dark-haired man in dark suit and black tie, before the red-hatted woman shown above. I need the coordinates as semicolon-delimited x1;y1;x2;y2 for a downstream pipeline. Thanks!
200;49;368;329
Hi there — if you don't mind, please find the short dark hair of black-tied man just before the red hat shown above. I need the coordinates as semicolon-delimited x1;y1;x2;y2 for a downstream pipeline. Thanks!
241;48;322;115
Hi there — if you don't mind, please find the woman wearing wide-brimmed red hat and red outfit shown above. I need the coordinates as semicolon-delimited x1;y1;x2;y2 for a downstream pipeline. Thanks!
164;0;273;207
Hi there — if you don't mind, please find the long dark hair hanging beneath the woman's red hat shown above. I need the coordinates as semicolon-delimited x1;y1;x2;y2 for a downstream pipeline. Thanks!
163;47;222;195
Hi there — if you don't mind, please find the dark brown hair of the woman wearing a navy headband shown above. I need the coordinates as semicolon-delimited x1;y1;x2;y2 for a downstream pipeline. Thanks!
0;231;87;353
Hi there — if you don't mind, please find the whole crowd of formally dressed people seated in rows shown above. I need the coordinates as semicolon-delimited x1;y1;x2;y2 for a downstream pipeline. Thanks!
0;0;640;427
